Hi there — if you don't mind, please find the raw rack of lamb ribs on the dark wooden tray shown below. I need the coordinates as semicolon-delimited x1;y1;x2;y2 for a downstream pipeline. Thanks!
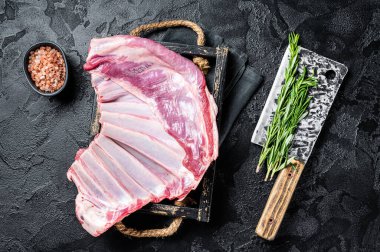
67;35;218;236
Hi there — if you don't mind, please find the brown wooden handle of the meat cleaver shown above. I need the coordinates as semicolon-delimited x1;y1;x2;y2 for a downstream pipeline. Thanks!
256;161;304;241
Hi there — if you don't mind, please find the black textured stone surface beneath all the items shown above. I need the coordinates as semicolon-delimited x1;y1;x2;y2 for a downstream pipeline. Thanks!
0;0;380;251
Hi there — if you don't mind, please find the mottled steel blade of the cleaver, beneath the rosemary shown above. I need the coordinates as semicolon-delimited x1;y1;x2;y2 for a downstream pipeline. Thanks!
251;47;348;164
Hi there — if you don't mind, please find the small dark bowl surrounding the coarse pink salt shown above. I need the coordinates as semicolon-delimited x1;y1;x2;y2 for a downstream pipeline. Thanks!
24;42;69;96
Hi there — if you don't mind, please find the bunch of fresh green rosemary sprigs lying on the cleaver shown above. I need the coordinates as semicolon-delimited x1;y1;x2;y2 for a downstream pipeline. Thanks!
256;33;317;180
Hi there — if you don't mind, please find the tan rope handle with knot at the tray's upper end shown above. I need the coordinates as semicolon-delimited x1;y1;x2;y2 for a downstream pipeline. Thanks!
129;19;210;75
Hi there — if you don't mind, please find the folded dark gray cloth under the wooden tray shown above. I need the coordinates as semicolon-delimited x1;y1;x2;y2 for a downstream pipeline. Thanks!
152;28;263;144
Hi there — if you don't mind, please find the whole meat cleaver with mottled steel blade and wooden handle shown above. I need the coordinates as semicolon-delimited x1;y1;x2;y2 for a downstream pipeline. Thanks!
251;47;348;240
